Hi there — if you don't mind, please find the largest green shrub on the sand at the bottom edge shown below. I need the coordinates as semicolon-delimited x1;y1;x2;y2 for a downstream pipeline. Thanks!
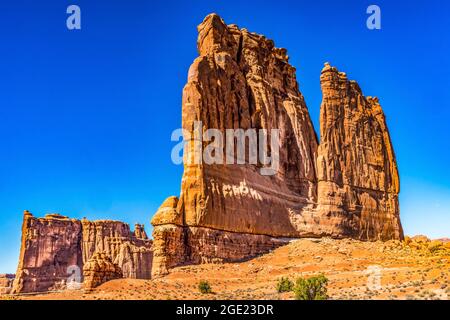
294;274;328;300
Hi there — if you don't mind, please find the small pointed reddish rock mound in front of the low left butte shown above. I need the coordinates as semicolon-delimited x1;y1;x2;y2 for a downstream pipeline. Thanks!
83;252;123;290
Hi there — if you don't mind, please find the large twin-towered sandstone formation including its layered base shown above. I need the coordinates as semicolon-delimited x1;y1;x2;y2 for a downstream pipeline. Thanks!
152;14;403;275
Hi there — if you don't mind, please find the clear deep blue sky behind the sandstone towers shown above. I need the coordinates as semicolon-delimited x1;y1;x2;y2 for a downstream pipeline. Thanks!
0;0;450;272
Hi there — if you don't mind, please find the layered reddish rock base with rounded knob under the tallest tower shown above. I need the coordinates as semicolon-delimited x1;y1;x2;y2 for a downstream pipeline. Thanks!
152;197;287;276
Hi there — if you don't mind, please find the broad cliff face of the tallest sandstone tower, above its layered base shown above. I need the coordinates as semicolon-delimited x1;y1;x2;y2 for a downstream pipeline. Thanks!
178;15;317;236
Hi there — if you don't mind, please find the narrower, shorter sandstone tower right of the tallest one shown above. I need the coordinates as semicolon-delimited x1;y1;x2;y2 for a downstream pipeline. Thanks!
317;64;403;240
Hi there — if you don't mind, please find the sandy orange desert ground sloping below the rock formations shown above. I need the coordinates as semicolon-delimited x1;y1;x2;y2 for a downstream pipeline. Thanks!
9;238;450;300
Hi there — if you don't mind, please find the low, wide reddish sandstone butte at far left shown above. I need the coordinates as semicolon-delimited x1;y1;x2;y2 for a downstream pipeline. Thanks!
13;211;153;293
